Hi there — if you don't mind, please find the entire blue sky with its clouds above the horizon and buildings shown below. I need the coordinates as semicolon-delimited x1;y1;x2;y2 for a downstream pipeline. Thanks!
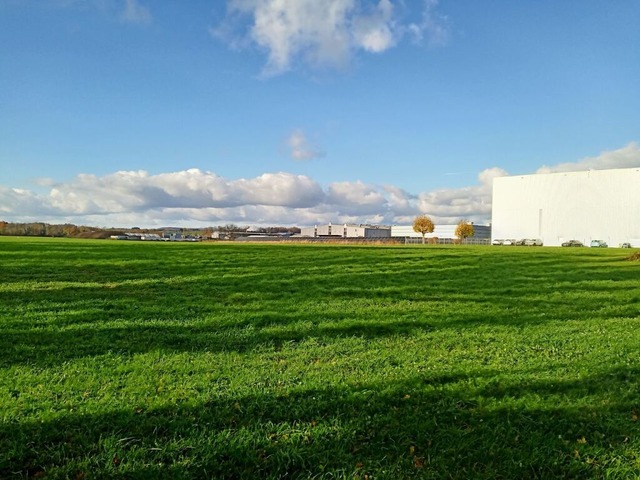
0;0;640;226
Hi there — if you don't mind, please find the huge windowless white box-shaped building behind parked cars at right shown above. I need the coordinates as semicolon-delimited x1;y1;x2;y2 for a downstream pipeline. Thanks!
491;168;640;247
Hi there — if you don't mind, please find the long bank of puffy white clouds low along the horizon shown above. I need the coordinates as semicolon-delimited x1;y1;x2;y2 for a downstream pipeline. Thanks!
0;143;640;227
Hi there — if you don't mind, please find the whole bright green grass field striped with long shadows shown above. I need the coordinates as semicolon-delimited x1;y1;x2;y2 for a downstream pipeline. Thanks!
0;238;640;480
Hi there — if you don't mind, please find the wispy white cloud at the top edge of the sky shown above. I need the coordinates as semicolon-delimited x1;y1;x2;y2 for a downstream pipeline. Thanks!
211;0;448;76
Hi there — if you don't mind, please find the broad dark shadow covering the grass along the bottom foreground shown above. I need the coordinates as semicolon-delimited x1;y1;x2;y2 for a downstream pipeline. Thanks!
0;369;640;479
